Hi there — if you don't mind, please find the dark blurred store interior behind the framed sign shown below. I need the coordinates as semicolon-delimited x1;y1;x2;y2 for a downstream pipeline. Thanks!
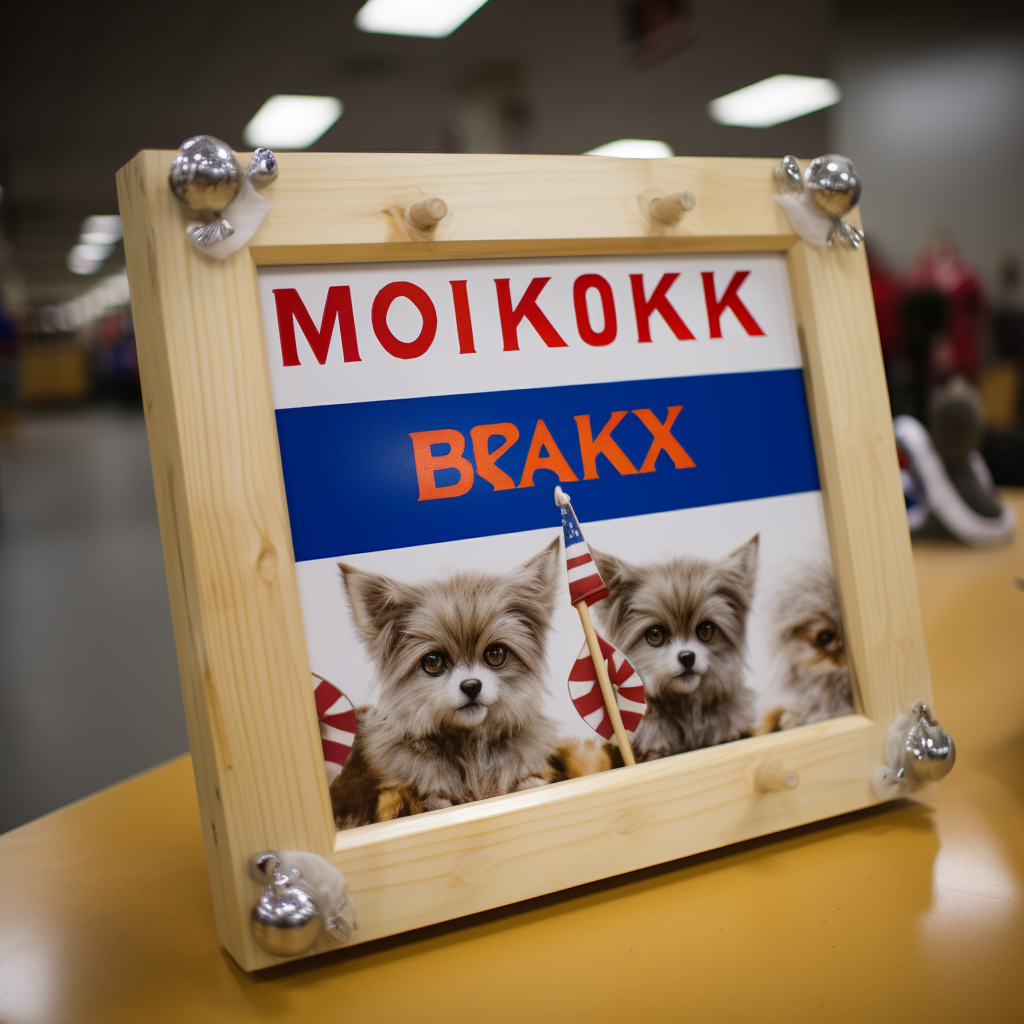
0;0;1024;831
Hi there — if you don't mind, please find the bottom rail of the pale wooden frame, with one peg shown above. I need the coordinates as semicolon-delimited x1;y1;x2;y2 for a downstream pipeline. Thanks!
323;715;885;949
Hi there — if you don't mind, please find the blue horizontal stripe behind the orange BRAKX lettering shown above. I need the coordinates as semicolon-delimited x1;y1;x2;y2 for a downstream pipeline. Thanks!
276;370;819;561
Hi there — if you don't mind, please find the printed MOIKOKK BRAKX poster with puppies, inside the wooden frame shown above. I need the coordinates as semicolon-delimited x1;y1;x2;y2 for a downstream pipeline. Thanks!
258;254;853;827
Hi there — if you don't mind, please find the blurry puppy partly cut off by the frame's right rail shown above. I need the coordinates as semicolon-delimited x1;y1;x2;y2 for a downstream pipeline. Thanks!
759;561;853;731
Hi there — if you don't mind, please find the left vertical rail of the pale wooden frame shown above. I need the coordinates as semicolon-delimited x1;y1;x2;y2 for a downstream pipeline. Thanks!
118;153;334;967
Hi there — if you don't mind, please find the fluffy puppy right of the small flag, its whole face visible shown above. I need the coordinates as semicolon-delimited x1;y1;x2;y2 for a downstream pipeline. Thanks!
591;537;758;761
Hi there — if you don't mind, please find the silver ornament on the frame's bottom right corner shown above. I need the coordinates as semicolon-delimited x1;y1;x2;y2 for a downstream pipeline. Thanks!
871;700;956;800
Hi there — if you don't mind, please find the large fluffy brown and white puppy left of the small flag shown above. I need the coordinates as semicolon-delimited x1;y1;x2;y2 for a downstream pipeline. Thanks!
331;540;611;828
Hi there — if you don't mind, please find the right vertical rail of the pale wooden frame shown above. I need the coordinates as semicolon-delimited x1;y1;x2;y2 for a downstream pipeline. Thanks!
786;242;932;722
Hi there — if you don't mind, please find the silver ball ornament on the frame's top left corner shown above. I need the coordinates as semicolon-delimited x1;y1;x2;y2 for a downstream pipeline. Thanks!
169;135;278;259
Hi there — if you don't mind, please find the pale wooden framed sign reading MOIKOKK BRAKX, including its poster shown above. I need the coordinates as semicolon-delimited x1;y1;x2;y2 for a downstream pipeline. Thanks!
118;152;930;970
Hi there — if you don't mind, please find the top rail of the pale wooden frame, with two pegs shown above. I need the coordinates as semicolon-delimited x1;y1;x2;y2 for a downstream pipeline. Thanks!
247;153;793;249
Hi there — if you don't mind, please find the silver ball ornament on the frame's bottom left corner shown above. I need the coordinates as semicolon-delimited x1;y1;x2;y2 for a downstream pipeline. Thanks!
250;850;355;956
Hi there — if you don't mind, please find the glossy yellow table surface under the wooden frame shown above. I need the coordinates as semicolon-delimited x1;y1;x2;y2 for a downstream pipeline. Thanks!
0;493;1024;1024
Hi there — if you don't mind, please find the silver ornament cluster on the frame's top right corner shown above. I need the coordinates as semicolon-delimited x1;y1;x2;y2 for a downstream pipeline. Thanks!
774;153;864;249
